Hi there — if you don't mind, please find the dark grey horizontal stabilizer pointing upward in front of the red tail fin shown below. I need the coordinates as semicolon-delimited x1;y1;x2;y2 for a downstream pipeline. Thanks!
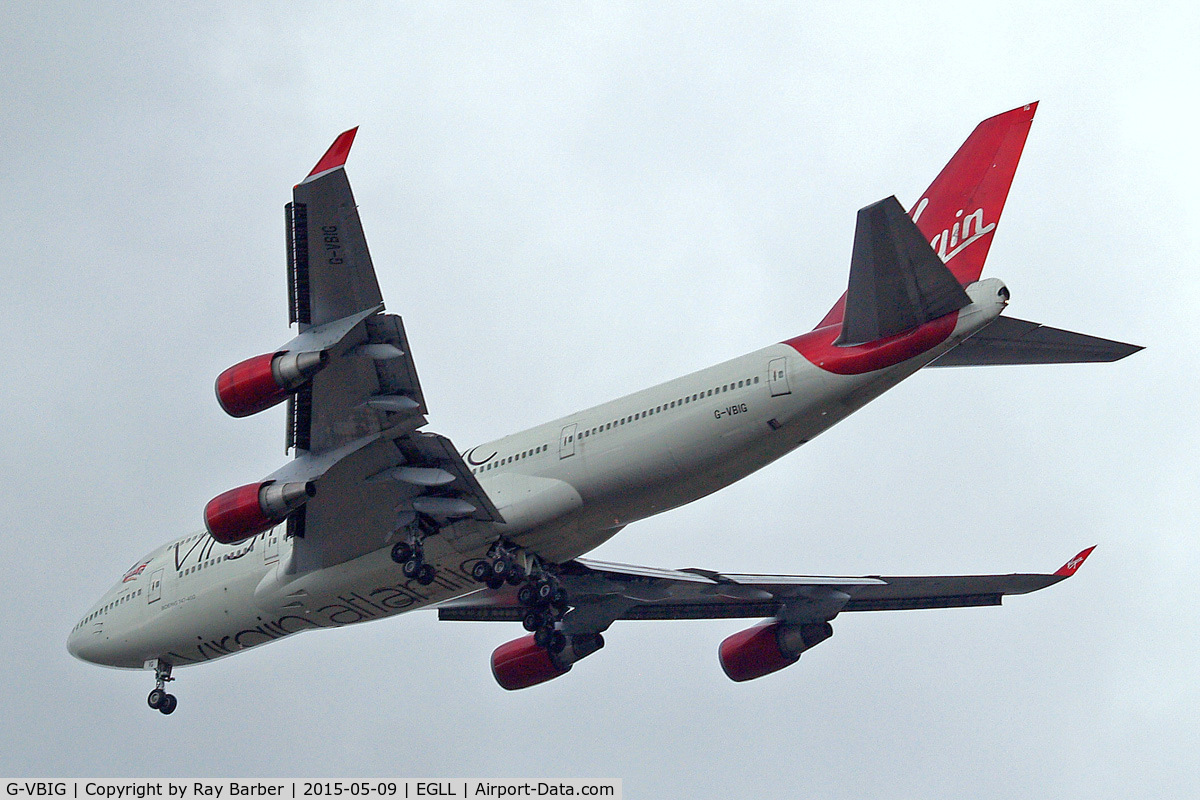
835;197;971;347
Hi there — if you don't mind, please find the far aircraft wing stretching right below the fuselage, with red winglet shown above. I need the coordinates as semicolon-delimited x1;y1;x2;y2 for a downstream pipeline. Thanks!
438;548;1093;633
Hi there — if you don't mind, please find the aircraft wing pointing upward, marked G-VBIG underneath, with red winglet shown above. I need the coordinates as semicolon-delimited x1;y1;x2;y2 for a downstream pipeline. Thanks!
271;128;500;571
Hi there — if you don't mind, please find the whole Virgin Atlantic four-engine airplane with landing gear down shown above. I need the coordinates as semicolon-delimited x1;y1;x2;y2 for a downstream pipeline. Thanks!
67;103;1141;714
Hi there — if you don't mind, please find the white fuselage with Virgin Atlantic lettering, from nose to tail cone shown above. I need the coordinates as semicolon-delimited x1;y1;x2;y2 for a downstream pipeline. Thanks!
68;281;1003;668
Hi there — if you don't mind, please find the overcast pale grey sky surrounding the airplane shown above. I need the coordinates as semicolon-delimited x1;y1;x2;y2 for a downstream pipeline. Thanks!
0;2;1200;799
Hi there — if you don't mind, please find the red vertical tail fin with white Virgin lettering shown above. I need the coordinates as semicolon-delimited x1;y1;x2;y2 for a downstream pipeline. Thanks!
817;103;1038;327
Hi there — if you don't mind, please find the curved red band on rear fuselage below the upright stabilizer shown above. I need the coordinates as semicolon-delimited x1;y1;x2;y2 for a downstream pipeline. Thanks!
784;312;959;375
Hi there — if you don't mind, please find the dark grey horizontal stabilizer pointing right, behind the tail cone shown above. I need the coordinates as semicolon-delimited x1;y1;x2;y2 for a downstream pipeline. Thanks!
930;317;1141;367
